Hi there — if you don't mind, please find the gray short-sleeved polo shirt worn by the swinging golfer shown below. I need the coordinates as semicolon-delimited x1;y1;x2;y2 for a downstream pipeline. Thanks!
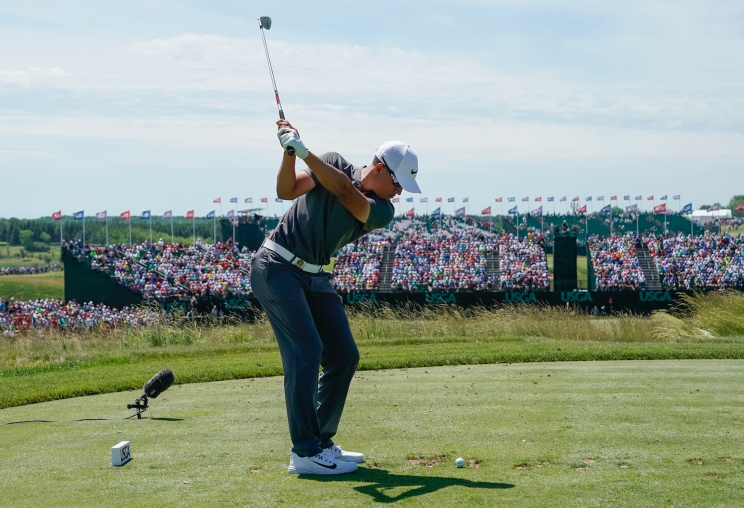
269;152;395;265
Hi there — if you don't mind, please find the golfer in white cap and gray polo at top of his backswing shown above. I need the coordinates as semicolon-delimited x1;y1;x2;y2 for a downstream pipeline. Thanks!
251;120;421;474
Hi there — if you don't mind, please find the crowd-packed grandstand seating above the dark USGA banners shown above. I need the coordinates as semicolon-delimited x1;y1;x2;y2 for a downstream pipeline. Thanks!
53;211;744;314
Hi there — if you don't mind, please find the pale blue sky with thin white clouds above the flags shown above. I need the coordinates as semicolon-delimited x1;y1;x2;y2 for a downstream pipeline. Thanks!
0;0;744;218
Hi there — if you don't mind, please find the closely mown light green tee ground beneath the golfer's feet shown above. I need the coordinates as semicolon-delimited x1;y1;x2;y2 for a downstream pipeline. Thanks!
0;360;744;507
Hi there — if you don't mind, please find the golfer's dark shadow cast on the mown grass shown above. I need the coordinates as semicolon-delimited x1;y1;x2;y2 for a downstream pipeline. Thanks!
300;468;514;503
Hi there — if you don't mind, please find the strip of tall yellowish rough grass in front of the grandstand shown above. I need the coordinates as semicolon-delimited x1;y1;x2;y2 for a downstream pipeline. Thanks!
0;293;744;367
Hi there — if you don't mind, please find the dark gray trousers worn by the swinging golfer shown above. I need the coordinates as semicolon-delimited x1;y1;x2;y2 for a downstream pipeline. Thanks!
251;247;359;457
